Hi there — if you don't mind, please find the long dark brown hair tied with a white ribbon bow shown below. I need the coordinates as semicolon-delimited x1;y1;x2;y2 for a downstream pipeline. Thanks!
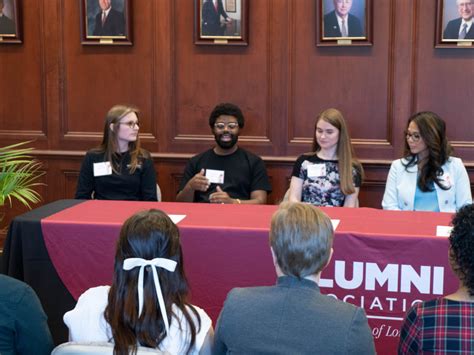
104;209;201;355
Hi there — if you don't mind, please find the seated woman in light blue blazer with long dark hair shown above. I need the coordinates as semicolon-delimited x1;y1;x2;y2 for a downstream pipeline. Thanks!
382;111;472;212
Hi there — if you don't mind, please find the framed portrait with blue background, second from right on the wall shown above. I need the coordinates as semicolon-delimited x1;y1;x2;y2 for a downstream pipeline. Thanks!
315;0;372;46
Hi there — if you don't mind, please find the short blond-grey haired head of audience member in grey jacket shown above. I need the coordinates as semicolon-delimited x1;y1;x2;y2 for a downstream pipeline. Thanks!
270;202;334;278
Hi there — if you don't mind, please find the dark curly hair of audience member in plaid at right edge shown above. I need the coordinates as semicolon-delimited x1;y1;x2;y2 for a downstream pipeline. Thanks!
449;204;474;296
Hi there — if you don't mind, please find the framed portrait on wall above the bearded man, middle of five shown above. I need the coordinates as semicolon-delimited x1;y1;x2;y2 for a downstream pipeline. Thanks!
194;0;248;46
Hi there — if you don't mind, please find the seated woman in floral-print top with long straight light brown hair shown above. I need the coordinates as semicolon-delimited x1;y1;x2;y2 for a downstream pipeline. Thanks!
289;108;363;207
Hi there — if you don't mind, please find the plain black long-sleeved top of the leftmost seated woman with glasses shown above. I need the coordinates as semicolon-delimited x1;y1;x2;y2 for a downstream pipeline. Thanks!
74;150;157;201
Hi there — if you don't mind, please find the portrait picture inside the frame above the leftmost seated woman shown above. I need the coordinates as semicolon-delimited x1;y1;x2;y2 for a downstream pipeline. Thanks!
87;0;126;37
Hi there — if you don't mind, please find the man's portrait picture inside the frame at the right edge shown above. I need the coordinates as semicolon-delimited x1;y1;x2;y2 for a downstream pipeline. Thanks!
443;0;474;41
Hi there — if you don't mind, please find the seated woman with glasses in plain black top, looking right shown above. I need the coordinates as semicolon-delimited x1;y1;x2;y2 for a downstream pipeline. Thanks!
75;105;157;201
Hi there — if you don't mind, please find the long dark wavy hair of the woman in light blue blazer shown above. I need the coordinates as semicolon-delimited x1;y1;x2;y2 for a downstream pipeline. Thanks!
403;111;453;192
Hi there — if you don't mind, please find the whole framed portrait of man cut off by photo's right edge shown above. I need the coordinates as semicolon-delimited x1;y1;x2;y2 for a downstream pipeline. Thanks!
435;0;474;48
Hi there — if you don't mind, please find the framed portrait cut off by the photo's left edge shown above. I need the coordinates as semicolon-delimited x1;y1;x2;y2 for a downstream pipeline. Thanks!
0;0;22;44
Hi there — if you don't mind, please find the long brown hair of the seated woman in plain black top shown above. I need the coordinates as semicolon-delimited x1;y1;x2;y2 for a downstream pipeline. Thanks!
95;105;149;174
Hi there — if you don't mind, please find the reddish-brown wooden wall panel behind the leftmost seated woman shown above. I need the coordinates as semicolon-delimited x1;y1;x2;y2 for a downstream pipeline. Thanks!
61;0;156;150
